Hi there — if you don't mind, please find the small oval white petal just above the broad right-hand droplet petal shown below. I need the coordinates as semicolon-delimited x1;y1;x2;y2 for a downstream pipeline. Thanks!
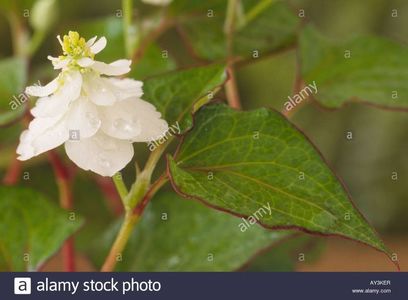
83;74;116;105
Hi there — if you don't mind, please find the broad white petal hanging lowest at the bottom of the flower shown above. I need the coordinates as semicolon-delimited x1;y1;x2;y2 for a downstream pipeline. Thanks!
65;132;134;176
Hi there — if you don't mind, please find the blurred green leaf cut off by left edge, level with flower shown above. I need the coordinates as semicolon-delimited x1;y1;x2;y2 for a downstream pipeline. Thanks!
0;58;27;126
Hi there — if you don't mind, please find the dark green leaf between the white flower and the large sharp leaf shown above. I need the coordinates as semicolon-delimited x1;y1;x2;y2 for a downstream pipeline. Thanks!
143;64;226;131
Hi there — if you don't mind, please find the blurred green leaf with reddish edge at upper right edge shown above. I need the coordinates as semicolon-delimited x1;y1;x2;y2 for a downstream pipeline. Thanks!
300;26;408;108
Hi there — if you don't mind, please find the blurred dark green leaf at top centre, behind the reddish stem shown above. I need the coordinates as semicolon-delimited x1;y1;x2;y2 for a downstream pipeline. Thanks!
178;1;299;60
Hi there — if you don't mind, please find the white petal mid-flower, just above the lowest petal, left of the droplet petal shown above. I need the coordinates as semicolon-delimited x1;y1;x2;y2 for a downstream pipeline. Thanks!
66;97;101;139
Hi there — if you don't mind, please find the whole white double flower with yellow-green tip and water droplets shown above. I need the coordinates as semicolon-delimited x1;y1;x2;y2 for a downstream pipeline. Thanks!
17;32;168;176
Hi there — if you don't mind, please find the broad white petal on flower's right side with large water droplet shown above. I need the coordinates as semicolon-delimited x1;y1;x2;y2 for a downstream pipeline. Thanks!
99;98;168;142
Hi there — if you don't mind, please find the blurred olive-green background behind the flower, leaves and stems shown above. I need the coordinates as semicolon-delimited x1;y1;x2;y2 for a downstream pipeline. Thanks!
0;0;408;270
